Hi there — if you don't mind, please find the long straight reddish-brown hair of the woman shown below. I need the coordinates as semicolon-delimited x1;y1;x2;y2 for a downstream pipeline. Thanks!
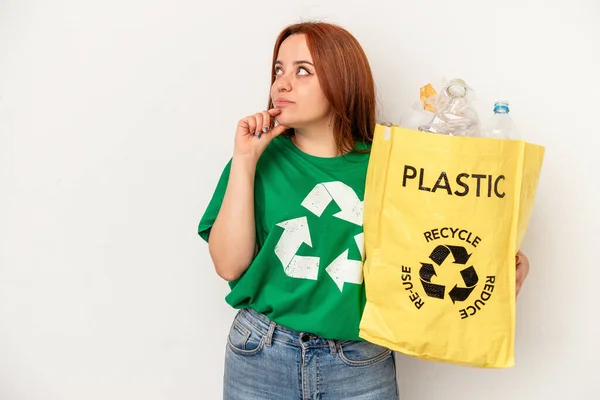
268;22;375;154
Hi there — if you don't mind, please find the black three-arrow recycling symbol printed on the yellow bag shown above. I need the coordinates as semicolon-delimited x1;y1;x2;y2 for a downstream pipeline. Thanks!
419;245;479;303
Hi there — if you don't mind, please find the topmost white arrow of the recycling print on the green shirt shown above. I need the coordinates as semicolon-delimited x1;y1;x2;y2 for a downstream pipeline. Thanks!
302;182;363;226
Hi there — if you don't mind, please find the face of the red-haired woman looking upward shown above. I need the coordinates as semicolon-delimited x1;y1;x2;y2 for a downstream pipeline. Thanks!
271;34;331;129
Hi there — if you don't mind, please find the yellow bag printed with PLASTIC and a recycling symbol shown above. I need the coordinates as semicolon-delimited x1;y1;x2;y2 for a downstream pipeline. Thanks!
360;124;544;368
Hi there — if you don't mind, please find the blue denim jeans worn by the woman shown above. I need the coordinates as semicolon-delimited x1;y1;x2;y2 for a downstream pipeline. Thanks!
223;309;398;400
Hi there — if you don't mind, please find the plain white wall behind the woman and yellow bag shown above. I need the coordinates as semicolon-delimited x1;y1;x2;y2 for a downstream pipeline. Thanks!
0;0;600;400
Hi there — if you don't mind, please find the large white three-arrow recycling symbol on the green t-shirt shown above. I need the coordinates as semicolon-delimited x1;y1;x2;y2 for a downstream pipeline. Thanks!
275;181;365;292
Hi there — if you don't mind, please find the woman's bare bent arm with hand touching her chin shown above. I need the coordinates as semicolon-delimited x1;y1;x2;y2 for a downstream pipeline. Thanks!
208;109;286;281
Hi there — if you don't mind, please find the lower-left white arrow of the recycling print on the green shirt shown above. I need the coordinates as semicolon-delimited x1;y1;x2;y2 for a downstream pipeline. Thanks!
275;217;319;280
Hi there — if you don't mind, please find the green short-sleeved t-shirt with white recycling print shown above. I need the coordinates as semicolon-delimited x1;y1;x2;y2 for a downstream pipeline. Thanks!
198;135;369;340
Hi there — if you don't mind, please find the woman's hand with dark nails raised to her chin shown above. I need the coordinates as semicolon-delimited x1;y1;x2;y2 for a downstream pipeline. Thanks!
233;108;287;161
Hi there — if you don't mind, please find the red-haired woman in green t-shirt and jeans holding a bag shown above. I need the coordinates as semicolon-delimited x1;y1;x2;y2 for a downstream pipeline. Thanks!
198;23;529;400
